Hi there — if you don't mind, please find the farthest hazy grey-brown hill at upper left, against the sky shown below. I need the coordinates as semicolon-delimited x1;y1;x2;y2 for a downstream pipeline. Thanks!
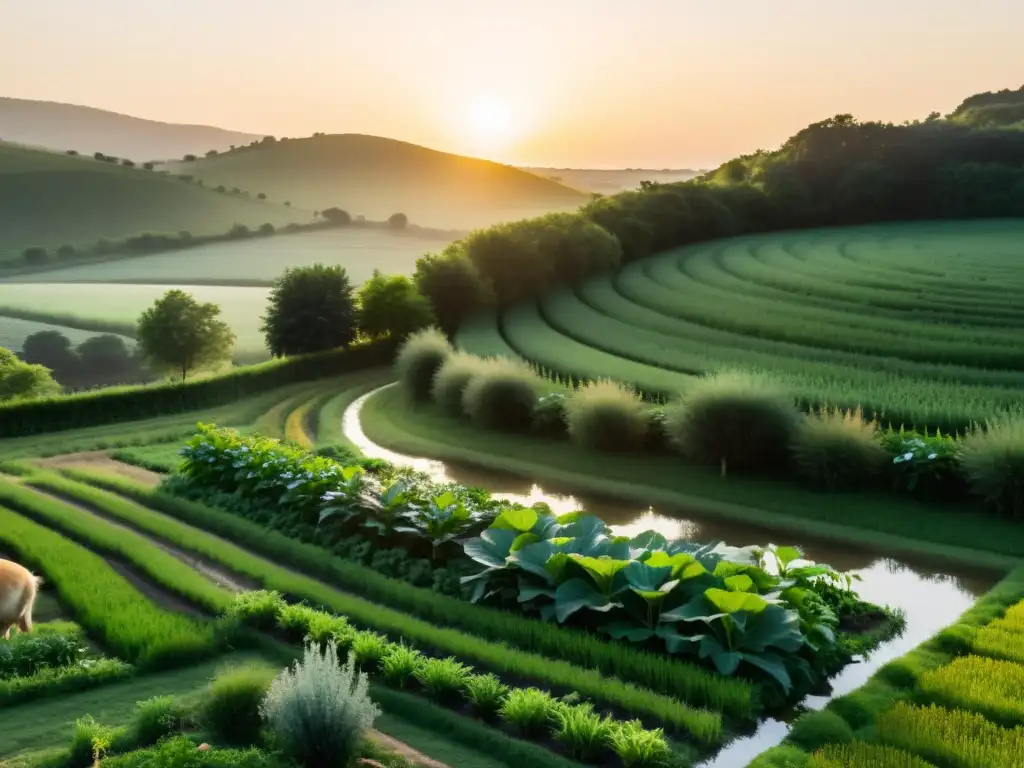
0;97;260;160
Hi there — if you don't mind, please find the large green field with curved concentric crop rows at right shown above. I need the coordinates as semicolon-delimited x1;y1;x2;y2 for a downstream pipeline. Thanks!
459;220;1024;429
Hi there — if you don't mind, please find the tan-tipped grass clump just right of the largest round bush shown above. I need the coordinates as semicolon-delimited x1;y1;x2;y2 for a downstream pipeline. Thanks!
793;408;889;490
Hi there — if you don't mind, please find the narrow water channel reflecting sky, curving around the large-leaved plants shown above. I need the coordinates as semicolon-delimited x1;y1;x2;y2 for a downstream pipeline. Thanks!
342;384;998;768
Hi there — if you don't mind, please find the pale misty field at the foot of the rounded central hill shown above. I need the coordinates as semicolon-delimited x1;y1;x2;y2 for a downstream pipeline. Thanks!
4;227;447;292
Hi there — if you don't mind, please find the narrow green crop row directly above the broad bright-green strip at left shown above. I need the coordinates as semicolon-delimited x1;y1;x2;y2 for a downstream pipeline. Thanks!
0;475;231;614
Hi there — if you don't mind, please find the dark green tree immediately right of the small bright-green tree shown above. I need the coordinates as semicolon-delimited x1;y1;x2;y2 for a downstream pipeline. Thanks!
414;243;495;335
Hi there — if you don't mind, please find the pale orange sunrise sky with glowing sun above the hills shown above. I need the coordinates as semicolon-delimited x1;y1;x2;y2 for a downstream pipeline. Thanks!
0;0;1024;168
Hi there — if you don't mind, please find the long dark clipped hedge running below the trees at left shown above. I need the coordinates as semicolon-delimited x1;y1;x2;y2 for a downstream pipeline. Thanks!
0;340;394;437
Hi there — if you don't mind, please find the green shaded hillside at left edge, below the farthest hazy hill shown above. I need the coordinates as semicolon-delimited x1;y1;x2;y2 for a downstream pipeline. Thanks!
0;142;311;261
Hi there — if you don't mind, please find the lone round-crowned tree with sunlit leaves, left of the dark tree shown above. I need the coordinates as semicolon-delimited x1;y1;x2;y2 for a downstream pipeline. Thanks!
137;289;234;381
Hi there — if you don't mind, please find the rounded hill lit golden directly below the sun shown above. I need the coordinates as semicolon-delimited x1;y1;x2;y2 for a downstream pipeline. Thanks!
166;134;588;229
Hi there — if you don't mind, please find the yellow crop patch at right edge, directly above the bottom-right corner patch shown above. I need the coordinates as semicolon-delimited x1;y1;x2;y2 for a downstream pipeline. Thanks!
920;655;1024;726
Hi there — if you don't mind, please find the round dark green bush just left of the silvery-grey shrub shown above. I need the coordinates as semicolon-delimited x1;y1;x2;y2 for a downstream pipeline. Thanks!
200;664;276;746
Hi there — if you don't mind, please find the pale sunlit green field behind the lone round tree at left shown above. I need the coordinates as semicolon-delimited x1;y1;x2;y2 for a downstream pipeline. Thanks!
0;283;268;352
